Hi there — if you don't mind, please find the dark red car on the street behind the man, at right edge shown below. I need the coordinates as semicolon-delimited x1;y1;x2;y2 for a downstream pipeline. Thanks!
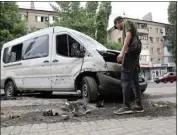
154;72;177;83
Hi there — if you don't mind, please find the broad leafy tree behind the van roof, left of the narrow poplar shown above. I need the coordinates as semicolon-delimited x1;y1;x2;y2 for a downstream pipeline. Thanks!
51;2;98;38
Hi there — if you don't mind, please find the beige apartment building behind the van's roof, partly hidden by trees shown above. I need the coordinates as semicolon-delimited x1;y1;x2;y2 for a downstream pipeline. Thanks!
19;2;56;31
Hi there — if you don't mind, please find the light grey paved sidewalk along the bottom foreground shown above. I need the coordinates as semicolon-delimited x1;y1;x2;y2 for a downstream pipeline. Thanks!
1;116;176;135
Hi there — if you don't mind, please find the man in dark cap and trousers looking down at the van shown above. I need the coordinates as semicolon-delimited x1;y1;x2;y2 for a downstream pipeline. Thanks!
114;16;144;114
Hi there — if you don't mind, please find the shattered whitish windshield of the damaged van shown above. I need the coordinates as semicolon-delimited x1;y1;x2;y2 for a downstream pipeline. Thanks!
74;32;107;51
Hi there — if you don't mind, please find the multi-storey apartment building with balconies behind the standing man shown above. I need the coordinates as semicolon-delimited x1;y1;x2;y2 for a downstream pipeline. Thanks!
107;14;175;80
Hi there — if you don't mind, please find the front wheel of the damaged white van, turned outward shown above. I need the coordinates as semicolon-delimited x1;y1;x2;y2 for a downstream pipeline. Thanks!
80;76;98;103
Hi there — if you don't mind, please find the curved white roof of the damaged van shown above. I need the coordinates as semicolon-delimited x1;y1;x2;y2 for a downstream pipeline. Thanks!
3;26;80;48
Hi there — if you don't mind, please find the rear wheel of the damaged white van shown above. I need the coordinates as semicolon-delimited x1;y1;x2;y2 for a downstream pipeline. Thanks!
4;81;17;97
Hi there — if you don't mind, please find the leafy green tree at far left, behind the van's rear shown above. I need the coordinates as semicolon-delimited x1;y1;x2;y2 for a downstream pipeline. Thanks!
0;1;27;49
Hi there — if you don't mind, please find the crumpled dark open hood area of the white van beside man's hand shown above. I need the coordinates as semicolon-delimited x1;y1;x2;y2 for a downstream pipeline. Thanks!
97;50;120;63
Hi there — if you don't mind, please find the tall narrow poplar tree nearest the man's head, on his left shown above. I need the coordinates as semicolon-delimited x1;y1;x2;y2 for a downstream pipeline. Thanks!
96;2;111;44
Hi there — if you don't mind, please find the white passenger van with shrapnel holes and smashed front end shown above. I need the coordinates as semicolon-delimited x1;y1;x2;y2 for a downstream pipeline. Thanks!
1;27;147;102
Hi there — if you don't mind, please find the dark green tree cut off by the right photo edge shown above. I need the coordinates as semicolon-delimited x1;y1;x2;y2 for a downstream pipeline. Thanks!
168;1;177;64
